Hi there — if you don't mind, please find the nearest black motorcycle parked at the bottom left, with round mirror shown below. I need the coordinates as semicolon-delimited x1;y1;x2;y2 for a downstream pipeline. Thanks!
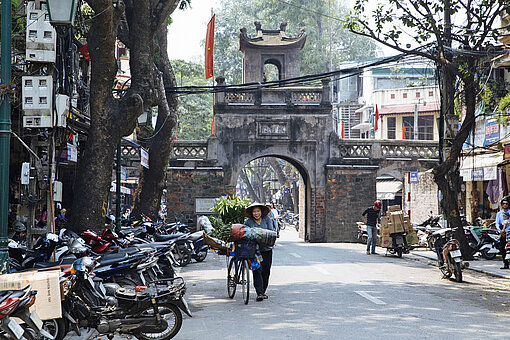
57;257;191;340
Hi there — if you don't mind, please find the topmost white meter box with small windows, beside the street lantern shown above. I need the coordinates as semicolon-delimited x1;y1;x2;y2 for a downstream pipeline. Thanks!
26;5;57;63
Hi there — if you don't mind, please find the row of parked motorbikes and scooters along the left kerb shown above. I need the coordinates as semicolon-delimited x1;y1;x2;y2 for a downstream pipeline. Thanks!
0;216;213;339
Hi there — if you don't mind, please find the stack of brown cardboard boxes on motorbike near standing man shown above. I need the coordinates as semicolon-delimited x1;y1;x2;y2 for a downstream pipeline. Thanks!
380;206;418;248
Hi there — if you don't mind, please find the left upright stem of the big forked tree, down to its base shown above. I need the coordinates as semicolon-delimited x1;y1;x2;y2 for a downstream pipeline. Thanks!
69;1;120;231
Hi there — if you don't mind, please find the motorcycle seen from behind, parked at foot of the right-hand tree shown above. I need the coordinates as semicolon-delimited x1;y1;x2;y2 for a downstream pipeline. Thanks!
430;228;469;282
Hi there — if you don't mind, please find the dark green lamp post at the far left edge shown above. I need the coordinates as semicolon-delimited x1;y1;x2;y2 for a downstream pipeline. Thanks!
0;0;12;274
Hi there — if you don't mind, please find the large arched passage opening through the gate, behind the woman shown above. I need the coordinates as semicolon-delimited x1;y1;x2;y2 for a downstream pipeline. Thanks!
236;156;310;239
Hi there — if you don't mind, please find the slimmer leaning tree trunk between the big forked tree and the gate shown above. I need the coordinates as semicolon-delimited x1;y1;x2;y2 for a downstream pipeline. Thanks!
133;25;178;219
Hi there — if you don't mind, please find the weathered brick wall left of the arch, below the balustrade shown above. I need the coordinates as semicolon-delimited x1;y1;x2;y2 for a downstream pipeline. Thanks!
166;168;227;222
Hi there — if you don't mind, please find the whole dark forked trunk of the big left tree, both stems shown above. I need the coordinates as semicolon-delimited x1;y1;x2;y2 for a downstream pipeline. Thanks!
69;0;179;232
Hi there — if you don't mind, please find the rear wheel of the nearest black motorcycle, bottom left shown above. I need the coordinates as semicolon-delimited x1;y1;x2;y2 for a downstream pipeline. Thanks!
135;303;182;340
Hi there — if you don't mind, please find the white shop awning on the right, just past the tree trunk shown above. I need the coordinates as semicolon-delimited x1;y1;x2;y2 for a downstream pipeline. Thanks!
460;152;503;181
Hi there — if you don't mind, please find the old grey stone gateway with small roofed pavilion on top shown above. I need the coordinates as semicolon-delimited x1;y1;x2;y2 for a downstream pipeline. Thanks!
163;22;437;242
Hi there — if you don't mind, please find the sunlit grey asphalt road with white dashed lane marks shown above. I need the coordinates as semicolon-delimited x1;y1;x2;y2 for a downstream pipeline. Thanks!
176;230;510;339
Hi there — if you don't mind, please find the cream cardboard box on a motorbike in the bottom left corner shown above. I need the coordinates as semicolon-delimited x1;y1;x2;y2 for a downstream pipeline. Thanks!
0;268;62;320
